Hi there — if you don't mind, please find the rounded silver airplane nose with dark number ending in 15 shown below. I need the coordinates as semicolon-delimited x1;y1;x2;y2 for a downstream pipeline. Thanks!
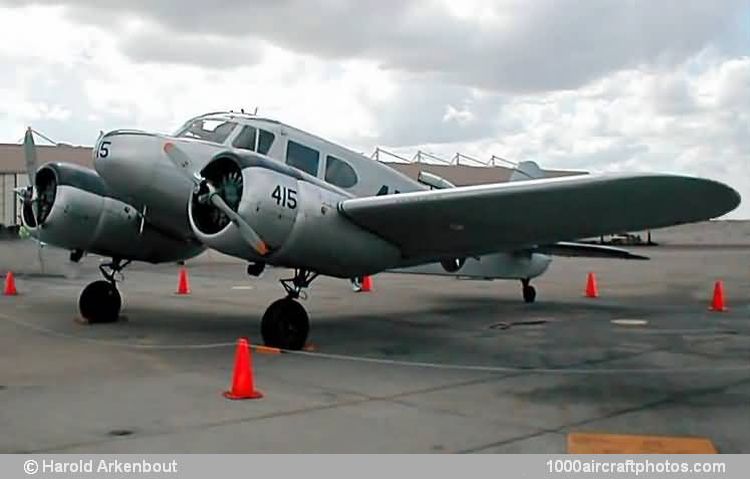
94;130;161;197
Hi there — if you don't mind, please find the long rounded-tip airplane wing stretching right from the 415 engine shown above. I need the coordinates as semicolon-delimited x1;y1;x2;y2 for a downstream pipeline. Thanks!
339;174;740;258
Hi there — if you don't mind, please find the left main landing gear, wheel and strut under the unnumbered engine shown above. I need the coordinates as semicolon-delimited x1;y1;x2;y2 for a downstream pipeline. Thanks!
78;258;130;323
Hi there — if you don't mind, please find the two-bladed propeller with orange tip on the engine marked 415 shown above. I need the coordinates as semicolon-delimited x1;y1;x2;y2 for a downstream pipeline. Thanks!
164;142;269;256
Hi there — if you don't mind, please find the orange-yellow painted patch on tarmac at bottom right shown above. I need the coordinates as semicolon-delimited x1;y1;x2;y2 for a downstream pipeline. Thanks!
568;432;718;454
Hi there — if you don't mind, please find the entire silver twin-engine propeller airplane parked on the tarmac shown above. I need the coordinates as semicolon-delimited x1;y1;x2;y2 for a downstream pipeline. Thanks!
14;113;740;349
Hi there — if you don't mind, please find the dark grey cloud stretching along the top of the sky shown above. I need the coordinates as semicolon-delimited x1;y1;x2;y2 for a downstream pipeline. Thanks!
5;0;745;93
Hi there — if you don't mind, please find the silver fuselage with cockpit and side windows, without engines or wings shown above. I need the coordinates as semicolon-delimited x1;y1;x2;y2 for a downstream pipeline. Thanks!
94;113;550;278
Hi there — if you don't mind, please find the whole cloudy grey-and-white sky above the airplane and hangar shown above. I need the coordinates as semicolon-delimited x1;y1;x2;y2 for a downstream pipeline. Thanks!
0;0;750;218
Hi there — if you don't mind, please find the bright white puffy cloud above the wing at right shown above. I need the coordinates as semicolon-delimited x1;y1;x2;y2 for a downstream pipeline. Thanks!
384;52;750;217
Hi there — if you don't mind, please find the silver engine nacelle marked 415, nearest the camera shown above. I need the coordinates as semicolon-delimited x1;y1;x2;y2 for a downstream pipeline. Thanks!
189;153;401;278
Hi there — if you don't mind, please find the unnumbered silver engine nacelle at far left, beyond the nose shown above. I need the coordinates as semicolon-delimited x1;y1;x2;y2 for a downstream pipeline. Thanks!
21;163;204;262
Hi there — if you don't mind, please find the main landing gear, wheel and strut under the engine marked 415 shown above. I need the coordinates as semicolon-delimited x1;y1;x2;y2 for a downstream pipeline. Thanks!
260;269;318;350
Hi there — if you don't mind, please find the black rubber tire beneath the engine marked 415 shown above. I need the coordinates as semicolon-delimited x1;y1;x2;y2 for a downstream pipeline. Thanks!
260;298;310;351
